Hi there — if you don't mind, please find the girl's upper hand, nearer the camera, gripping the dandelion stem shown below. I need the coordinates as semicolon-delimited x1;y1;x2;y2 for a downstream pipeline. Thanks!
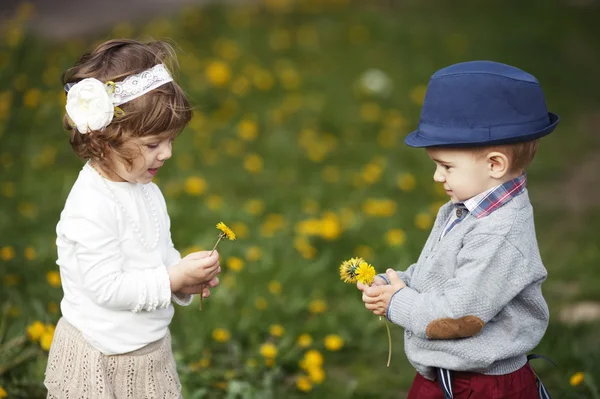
167;251;221;292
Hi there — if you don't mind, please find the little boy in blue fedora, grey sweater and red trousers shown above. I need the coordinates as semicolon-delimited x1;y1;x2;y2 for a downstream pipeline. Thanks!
359;61;559;399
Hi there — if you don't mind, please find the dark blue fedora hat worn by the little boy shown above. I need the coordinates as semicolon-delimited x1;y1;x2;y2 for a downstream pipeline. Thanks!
404;61;560;147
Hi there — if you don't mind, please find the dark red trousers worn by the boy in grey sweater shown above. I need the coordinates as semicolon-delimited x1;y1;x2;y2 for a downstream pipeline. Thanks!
407;363;539;399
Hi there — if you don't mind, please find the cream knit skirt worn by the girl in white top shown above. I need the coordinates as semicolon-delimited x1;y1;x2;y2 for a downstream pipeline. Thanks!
44;318;183;399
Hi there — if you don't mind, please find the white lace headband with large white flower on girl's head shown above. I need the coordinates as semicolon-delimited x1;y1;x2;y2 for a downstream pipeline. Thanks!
65;64;173;134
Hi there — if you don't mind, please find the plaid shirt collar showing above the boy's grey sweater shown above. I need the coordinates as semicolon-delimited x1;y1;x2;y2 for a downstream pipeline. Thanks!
440;173;527;238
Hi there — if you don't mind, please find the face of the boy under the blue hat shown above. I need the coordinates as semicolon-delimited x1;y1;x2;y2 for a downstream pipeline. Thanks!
427;148;498;203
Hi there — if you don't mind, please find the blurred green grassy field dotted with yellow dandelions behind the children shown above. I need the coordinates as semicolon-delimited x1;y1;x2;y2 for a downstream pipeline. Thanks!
0;0;600;399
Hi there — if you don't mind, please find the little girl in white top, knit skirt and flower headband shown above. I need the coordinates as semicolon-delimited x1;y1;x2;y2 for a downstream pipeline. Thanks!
44;40;221;398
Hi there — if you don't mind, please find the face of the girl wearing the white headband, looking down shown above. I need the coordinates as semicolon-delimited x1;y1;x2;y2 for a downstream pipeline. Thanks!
103;136;172;184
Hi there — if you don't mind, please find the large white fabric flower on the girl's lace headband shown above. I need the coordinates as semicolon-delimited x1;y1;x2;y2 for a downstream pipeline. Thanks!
66;78;115;134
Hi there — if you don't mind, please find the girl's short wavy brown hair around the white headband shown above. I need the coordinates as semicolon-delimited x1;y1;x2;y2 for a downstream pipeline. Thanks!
62;39;192;170
